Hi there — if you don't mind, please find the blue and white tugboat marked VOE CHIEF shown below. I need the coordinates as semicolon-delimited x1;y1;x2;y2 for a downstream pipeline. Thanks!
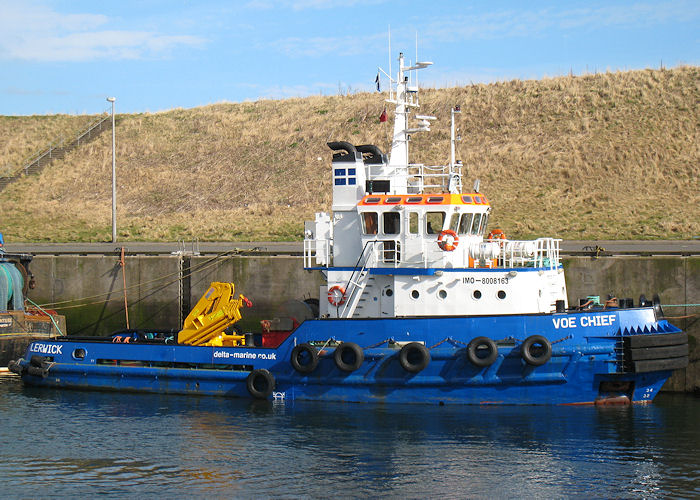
10;55;688;404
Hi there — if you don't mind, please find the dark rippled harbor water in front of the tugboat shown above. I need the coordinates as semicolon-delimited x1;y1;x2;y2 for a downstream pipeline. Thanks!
0;376;700;498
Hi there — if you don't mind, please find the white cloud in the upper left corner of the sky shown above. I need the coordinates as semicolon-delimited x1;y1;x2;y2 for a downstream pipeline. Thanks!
0;0;206;62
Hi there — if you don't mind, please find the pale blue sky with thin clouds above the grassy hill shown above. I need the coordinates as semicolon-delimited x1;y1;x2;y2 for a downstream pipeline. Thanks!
0;0;700;115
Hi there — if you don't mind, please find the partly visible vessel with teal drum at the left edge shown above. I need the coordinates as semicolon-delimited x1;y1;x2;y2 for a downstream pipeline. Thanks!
0;233;66;370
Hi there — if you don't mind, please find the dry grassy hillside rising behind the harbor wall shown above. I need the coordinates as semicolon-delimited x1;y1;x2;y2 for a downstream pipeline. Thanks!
0;67;700;241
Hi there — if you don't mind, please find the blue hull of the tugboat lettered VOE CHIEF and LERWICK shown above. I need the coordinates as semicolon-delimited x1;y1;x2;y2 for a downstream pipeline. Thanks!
13;308;687;404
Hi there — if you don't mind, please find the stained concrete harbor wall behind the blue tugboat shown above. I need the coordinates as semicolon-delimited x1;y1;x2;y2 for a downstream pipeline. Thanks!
24;255;700;391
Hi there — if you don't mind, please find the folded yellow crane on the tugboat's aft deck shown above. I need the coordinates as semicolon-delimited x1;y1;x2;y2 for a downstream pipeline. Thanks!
177;281;253;347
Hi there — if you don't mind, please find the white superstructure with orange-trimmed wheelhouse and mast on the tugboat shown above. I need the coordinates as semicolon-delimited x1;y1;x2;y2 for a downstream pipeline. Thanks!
304;54;567;318
